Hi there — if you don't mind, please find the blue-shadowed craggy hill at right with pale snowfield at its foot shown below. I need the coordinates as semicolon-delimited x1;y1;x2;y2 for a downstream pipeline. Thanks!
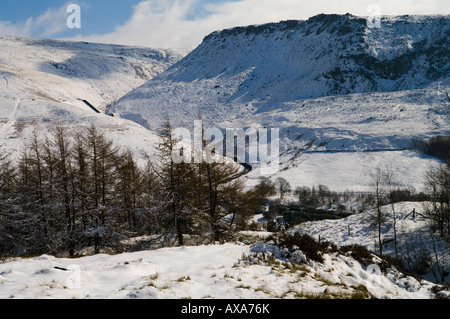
109;15;450;191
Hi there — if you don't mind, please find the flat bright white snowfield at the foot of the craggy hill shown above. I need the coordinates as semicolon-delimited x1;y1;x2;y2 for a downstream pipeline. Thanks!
248;151;440;192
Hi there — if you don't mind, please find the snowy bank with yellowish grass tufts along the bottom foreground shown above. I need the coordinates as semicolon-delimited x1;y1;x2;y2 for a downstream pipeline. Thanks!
0;243;444;300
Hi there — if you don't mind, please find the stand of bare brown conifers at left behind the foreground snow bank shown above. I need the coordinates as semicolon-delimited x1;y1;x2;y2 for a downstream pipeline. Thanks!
0;120;265;256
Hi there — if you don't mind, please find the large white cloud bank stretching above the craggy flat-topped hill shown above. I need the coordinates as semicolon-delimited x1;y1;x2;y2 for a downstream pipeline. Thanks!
73;0;450;48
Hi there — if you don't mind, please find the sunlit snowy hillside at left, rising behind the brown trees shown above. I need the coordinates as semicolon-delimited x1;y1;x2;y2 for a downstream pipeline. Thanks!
0;36;186;160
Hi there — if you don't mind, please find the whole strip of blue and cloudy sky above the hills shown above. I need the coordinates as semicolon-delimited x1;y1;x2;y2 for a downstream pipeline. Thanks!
0;0;450;49
